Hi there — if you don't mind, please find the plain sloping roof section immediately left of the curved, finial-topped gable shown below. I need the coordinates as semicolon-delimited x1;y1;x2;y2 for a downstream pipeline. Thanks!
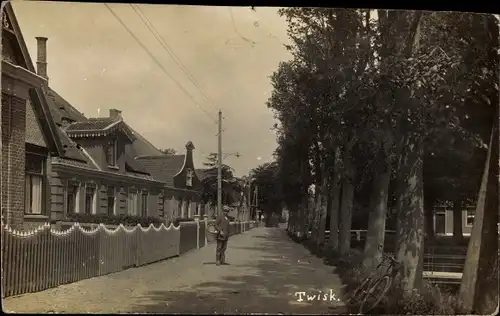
136;155;186;186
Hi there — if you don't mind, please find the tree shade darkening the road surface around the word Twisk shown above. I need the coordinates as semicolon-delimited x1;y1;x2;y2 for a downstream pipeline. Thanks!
131;228;346;314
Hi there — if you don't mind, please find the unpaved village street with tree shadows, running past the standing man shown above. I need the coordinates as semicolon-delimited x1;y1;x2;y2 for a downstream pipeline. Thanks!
4;227;344;314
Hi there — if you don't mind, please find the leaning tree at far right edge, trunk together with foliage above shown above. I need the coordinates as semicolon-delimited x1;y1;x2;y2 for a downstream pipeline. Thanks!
459;15;500;314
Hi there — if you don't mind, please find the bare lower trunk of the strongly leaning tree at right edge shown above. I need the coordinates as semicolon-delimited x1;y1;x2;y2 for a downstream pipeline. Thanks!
458;123;499;313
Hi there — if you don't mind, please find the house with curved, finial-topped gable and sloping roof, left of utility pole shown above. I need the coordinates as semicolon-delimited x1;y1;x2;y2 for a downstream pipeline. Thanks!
136;142;202;219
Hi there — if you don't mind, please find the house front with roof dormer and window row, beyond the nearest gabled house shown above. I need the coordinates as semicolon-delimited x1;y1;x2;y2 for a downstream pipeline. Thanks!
52;110;164;218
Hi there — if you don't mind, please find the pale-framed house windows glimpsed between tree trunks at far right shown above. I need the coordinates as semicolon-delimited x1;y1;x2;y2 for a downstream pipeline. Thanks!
433;206;476;236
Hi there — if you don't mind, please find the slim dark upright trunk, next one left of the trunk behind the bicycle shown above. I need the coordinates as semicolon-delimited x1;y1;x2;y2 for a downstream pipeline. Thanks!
338;179;354;256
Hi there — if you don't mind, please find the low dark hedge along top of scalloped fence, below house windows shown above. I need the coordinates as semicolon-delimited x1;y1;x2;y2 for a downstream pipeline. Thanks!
66;213;163;227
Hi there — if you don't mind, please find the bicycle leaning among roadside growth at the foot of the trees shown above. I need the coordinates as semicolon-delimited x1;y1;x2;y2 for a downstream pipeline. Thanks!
348;246;401;314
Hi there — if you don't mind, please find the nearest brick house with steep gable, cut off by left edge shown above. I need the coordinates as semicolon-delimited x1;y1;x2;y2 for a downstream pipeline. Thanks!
0;3;64;229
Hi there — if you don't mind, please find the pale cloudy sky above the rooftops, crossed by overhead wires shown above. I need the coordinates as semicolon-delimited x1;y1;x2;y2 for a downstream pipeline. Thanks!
12;1;291;176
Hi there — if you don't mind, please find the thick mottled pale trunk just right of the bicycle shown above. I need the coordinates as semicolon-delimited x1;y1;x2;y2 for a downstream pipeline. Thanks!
396;133;424;294
